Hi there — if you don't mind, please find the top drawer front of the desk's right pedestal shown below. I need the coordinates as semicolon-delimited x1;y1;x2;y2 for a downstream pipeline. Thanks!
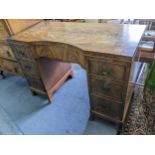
88;60;126;80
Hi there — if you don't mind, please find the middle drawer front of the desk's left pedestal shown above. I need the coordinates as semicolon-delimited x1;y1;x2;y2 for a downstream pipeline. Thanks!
20;60;39;76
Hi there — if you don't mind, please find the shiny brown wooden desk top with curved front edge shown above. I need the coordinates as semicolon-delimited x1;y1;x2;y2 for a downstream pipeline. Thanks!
10;21;146;57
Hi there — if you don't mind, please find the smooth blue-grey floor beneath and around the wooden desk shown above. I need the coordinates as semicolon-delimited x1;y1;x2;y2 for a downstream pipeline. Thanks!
0;64;117;135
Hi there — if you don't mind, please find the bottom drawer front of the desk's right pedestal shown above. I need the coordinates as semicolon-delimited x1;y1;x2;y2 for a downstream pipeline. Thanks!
91;95;123;120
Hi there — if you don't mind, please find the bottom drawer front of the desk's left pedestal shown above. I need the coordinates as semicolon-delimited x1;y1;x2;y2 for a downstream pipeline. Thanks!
26;77;45;92
